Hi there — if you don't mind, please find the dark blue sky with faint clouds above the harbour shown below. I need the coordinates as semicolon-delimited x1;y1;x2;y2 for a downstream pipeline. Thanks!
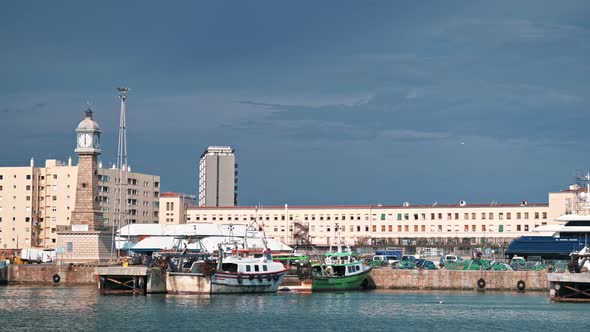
0;0;590;206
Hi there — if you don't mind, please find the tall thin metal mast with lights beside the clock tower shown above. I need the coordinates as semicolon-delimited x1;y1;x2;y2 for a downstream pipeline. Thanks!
115;88;129;258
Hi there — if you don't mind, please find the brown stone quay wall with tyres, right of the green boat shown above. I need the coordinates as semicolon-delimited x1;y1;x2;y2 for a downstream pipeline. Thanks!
371;268;549;291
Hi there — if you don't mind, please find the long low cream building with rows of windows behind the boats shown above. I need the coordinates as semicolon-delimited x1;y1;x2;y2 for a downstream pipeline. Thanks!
186;188;579;246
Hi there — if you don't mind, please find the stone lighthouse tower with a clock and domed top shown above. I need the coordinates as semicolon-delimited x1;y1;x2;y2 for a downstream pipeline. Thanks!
57;108;112;262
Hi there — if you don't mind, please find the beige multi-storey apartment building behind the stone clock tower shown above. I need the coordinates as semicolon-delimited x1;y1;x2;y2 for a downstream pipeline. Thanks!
0;158;160;249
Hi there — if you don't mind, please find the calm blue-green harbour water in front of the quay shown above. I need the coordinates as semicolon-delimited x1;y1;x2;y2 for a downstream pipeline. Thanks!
0;285;590;332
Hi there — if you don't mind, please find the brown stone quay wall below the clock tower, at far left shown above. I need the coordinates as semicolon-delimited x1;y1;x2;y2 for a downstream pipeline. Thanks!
8;264;97;285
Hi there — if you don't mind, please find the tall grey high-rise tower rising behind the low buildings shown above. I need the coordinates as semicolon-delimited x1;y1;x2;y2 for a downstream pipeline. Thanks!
199;146;238;206
